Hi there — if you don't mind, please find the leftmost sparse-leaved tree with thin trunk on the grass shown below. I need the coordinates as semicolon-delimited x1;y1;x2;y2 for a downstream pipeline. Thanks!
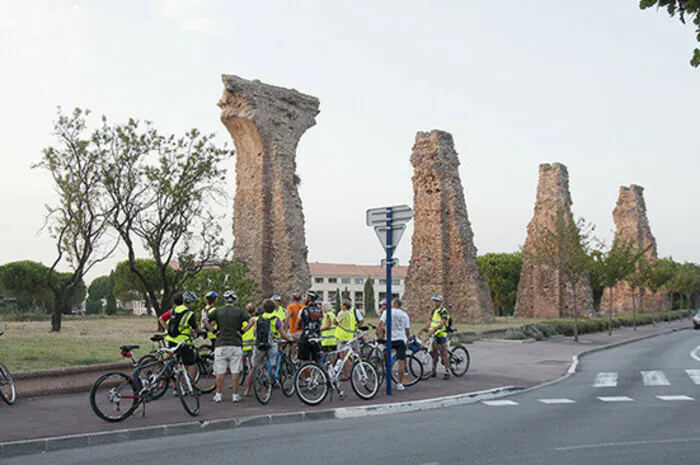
33;108;118;332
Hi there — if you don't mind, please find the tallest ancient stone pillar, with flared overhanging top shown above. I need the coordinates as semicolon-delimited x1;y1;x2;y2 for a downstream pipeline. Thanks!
219;75;319;299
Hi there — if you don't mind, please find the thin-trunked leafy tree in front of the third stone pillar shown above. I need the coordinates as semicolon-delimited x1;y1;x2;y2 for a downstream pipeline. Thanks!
532;208;592;342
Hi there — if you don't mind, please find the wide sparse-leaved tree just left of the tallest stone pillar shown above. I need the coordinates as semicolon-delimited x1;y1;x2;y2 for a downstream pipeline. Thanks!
93;117;233;315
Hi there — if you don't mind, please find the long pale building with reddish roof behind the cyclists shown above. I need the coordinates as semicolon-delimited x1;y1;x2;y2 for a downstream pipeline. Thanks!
309;262;408;310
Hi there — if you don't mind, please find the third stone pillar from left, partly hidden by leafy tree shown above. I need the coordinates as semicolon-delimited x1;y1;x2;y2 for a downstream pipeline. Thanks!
515;163;593;318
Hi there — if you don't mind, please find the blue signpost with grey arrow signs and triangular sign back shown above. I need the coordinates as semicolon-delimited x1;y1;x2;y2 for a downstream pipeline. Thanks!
367;205;415;396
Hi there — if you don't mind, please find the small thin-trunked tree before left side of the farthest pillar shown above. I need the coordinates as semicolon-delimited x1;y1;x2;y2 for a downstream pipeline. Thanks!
592;239;648;335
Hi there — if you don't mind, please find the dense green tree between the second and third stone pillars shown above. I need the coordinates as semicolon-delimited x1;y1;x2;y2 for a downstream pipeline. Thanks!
476;252;523;316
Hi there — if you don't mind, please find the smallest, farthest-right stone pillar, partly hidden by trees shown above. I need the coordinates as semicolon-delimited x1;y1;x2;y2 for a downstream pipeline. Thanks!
600;184;671;314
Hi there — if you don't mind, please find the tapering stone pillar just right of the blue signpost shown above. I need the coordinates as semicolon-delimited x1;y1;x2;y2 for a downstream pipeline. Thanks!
405;131;493;322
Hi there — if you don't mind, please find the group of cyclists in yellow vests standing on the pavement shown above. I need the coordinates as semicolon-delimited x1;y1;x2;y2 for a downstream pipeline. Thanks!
159;289;452;403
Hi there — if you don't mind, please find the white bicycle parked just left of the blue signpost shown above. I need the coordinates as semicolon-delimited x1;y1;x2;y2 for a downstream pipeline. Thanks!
294;327;380;405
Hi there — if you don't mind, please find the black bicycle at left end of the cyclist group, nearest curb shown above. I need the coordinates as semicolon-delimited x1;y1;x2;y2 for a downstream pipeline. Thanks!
90;341;199;423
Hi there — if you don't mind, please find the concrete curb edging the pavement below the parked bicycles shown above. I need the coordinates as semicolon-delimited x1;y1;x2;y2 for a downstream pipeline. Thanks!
0;386;523;458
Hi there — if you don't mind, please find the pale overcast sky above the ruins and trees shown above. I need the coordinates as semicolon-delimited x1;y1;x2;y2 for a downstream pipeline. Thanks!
0;0;700;281
